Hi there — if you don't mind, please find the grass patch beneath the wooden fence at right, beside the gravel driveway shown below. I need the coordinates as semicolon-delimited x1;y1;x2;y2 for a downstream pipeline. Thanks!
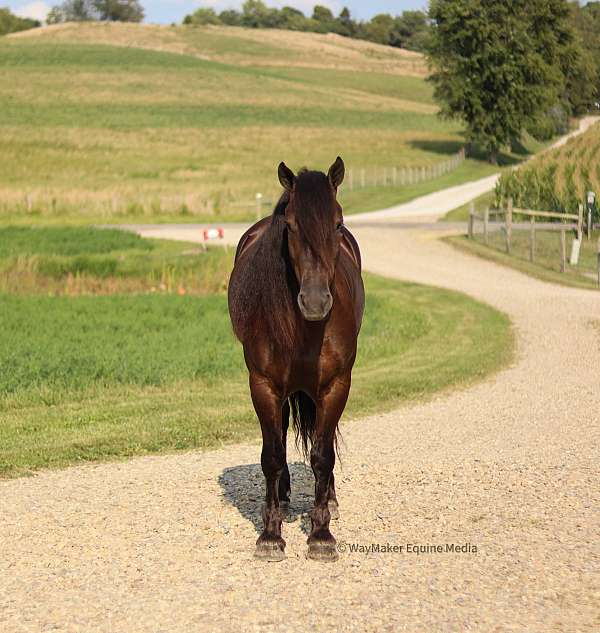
445;230;600;289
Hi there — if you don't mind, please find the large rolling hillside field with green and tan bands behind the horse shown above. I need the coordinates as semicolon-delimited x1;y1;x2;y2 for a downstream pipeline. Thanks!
0;23;502;223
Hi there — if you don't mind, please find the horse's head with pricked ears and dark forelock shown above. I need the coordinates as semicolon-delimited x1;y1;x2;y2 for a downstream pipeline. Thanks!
279;156;344;321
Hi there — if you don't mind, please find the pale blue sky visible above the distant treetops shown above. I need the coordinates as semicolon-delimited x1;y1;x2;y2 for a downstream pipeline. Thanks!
10;0;427;24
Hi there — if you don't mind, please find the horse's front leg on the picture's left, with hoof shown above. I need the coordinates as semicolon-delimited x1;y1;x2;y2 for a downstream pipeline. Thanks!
250;374;286;561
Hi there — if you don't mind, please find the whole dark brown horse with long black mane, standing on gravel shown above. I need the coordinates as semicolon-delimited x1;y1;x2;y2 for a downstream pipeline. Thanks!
229;157;364;560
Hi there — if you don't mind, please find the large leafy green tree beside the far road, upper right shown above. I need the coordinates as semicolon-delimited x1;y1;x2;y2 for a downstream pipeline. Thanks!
429;0;568;163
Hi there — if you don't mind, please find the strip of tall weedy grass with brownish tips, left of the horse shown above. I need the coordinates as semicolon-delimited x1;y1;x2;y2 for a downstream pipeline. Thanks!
0;226;233;295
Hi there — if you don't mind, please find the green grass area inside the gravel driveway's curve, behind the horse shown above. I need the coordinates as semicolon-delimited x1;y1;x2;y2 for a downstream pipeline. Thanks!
0;227;512;477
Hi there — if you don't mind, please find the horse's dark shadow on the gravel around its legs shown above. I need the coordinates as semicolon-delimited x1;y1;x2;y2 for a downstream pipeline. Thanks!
219;462;315;534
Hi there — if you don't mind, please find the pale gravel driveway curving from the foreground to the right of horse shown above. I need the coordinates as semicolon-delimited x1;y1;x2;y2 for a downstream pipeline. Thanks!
0;217;600;633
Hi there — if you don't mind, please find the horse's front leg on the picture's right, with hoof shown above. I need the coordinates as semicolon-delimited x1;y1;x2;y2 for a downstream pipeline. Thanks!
308;377;350;561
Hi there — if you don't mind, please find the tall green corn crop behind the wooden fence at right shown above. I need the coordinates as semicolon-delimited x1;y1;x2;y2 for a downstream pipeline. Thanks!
496;123;600;213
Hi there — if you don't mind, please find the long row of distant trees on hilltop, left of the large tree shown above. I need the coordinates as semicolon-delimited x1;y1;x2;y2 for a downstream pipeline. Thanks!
183;0;431;51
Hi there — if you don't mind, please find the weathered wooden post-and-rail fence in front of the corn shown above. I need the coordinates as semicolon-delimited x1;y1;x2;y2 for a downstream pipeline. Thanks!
469;198;584;272
